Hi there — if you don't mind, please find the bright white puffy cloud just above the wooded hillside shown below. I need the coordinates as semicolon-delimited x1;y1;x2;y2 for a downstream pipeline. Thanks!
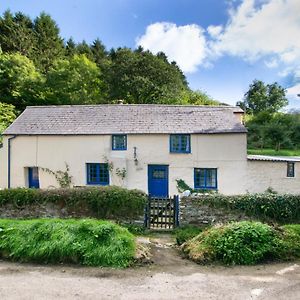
136;22;207;73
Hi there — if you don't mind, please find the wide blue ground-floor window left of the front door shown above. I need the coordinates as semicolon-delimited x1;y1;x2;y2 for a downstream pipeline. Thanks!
86;163;109;185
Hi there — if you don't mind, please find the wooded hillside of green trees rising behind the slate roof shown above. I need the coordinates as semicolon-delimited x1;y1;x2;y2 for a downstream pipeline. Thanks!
0;11;218;112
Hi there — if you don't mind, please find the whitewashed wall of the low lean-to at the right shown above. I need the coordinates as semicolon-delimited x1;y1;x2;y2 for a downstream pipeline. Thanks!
247;160;300;194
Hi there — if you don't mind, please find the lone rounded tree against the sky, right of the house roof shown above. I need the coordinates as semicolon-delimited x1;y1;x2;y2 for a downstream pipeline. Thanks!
237;80;288;114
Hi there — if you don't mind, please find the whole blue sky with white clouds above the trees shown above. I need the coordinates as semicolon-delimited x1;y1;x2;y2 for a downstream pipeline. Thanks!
0;0;300;108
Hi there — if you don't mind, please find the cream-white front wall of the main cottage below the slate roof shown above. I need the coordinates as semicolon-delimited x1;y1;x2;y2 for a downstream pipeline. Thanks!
0;133;247;195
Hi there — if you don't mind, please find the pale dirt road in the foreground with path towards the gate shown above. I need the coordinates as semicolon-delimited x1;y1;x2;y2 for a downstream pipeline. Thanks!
0;239;300;300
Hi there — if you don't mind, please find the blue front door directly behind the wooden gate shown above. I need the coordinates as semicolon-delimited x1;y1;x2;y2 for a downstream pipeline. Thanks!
148;165;169;198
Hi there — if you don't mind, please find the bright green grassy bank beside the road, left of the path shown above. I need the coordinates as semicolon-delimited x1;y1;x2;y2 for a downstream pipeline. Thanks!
0;219;135;267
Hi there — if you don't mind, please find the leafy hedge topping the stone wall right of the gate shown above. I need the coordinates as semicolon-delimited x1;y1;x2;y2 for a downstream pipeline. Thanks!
184;193;300;224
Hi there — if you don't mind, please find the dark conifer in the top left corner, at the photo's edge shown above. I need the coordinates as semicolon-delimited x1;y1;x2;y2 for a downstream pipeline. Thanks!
0;11;35;57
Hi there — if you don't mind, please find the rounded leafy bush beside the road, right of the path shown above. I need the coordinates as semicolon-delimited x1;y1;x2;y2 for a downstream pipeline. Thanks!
182;221;300;265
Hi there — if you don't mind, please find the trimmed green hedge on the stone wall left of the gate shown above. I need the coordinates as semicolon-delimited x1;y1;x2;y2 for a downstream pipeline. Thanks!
0;186;147;219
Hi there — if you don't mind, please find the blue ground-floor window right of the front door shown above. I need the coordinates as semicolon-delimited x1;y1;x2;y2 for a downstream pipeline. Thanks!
194;168;218;190
